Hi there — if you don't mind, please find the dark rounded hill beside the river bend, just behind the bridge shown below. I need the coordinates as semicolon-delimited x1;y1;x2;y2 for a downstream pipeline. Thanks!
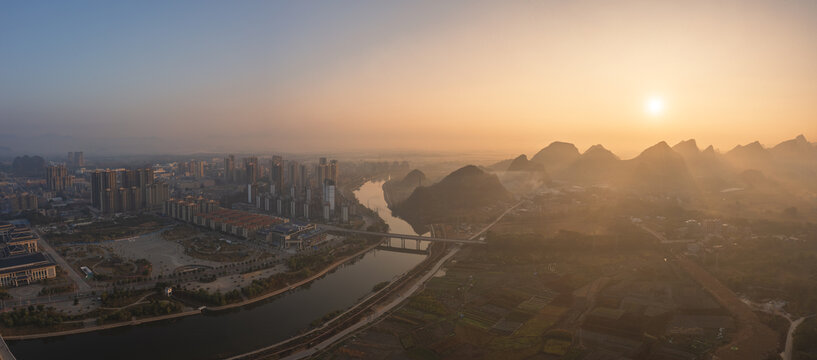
392;165;512;228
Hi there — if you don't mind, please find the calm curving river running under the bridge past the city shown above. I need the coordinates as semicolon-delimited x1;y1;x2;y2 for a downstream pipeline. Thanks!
8;182;427;360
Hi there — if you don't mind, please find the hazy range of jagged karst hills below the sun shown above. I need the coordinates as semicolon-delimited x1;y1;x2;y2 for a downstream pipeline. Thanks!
531;135;817;194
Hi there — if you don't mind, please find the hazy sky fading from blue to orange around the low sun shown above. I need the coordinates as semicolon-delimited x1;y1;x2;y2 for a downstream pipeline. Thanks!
0;0;817;157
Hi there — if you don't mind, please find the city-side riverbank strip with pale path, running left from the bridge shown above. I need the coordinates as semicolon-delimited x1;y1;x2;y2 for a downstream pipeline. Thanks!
3;239;380;341
